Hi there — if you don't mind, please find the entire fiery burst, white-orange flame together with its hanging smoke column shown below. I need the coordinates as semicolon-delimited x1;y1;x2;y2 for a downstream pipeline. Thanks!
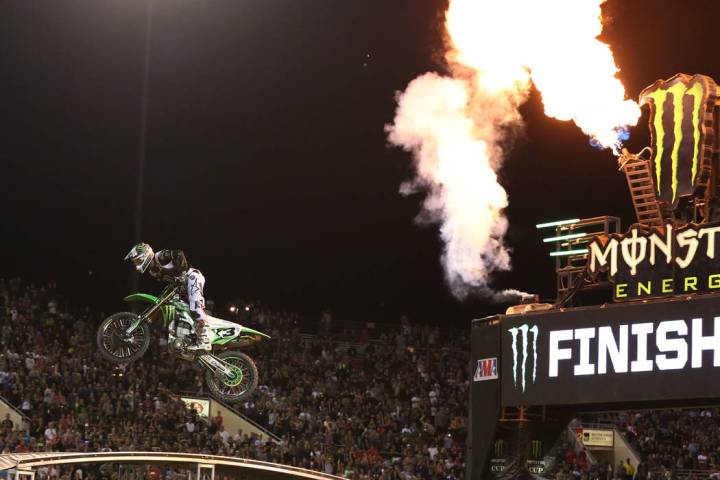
386;0;639;301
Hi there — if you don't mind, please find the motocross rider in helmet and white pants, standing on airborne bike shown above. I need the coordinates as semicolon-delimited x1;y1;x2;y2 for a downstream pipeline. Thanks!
125;243;212;352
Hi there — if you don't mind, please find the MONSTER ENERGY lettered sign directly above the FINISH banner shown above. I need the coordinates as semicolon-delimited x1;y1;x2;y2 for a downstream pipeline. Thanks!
588;223;720;301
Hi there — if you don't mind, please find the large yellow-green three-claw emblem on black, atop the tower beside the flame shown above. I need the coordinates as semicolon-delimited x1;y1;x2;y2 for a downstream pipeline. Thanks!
640;75;716;203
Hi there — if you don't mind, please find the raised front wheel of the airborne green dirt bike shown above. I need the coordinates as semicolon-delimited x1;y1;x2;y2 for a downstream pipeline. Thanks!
97;312;150;363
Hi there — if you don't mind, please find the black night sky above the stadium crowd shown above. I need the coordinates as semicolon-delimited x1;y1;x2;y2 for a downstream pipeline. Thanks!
0;0;720;325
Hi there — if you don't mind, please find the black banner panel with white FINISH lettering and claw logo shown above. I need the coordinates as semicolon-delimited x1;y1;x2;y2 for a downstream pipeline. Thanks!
501;295;720;406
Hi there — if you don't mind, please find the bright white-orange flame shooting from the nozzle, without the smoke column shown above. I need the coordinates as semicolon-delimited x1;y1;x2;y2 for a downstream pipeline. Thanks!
446;0;640;152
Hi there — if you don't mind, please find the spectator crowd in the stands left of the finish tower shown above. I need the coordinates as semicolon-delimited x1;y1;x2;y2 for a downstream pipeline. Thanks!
0;279;469;480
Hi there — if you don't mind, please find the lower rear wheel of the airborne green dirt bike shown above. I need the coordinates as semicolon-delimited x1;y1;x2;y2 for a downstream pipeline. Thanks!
205;350;258;402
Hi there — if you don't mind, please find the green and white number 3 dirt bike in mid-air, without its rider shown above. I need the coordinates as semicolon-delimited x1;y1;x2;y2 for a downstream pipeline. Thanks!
97;284;270;402
